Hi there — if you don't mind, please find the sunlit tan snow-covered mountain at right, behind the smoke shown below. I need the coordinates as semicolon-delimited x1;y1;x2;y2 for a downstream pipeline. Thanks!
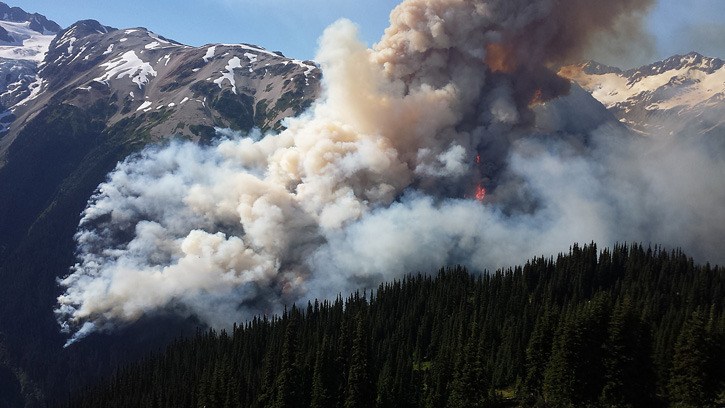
559;52;725;135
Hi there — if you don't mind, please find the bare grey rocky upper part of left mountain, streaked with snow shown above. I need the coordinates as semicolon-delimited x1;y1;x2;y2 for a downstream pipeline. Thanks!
0;14;321;166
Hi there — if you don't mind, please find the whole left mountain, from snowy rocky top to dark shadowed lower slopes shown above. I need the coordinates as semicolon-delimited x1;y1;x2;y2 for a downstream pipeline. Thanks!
0;3;321;407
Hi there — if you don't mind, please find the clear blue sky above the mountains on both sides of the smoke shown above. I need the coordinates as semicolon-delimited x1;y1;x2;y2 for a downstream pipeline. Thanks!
11;0;725;63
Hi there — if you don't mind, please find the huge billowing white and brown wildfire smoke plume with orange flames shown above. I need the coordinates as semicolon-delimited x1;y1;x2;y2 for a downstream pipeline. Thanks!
56;0;725;343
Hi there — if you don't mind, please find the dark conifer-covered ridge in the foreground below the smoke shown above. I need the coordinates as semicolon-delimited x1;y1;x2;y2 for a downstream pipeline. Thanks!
65;243;725;408
